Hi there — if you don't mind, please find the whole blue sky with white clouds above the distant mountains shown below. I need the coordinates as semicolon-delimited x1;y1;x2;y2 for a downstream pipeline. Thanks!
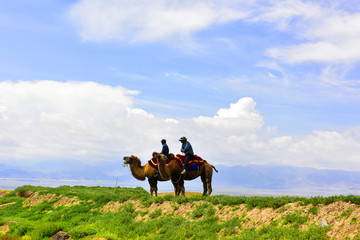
0;0;360;174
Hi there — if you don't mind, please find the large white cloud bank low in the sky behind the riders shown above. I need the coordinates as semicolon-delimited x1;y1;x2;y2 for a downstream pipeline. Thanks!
0;81;360;170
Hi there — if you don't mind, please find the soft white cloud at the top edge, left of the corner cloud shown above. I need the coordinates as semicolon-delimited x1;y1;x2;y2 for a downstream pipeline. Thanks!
70;0;248;42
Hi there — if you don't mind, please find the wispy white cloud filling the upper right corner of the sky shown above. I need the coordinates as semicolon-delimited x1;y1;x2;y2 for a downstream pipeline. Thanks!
258;0;360;63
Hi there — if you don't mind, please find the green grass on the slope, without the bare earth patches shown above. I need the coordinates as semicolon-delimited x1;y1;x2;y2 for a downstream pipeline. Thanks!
0;185;360;240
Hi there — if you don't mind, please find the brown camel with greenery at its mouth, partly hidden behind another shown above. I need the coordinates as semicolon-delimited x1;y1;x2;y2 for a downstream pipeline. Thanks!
124;152;181;196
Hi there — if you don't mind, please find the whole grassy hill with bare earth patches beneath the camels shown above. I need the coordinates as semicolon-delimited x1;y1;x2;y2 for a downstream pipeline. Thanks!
0;186;360;240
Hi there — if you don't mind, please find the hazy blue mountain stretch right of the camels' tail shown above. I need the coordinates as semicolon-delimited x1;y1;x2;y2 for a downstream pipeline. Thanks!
214;165;360;190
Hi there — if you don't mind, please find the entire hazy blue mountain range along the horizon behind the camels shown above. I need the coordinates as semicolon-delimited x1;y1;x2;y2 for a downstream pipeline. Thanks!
0;164;360;195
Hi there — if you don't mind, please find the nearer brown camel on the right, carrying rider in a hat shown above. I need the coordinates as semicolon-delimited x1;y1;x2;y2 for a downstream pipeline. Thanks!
155;153;218;196
